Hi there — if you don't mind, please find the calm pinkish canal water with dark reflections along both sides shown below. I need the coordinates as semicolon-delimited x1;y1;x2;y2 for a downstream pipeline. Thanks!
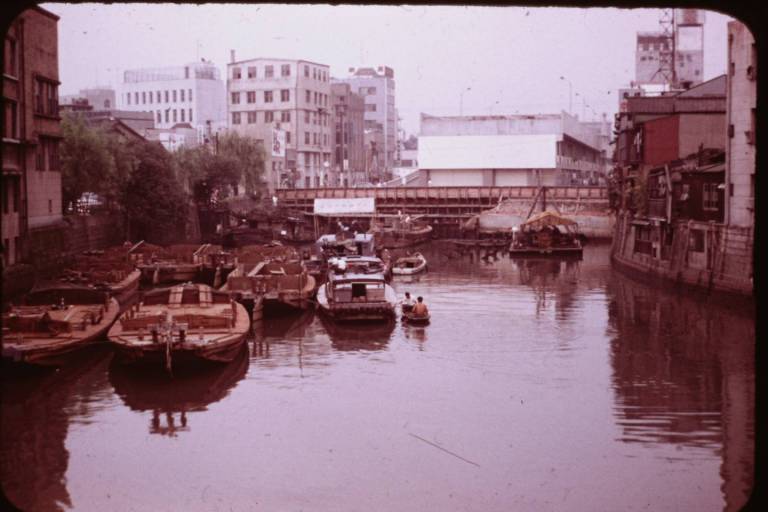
0;245;755;511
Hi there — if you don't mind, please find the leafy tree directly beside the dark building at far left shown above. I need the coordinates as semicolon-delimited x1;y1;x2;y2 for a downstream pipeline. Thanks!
60;115;115;209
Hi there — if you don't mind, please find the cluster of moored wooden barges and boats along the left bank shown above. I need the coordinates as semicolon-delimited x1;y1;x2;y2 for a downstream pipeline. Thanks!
2;234;426;371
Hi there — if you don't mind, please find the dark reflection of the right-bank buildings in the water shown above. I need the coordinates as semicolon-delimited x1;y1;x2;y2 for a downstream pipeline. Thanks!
608;272;755;510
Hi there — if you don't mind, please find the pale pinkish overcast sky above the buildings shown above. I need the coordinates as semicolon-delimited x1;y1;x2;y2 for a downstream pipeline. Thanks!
42;3;730;134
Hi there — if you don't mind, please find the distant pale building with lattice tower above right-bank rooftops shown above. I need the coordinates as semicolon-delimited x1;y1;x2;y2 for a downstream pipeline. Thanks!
635;9;704;89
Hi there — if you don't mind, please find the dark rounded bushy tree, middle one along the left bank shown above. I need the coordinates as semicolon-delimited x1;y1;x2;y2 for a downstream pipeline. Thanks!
124;142;188;244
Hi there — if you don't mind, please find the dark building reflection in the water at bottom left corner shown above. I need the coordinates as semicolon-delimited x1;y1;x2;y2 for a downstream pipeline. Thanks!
0;347;112;510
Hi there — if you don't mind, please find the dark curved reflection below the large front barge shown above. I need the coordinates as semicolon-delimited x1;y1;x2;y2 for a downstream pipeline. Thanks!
109;344;250;436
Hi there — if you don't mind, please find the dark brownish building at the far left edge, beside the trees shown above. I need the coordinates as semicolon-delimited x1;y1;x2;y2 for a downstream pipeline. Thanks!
2;7;62;267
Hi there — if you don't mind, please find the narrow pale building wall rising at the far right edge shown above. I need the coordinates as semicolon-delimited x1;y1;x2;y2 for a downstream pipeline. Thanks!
725;21;757;227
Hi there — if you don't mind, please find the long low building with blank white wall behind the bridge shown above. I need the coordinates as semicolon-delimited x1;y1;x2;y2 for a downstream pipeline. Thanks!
417;112;605;186
